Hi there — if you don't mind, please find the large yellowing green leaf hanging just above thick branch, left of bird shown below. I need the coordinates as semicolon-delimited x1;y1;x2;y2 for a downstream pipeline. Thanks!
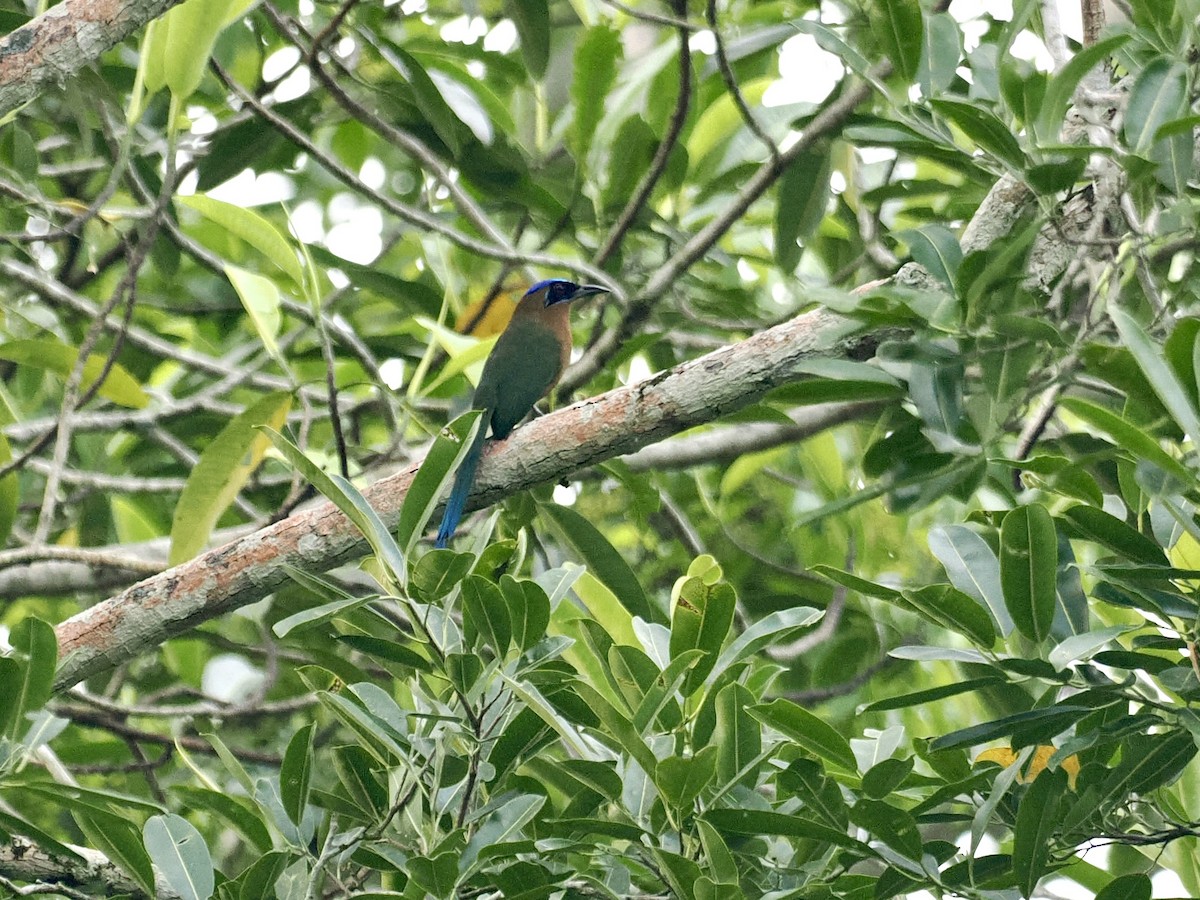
168;391;292;565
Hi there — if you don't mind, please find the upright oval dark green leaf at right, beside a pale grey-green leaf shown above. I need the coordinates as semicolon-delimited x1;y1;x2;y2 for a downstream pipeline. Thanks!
1000;503;1058;643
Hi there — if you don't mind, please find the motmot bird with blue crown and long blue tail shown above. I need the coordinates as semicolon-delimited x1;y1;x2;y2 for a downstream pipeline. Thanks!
434;278;608;547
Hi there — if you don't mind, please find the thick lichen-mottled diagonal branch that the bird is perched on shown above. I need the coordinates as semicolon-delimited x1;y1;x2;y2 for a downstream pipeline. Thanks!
55;310;880;691
